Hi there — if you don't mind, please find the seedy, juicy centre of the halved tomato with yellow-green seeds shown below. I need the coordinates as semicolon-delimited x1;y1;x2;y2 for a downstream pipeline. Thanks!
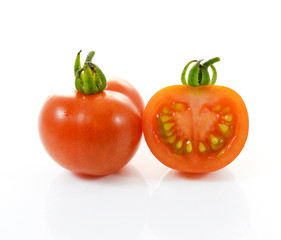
156;102;235;157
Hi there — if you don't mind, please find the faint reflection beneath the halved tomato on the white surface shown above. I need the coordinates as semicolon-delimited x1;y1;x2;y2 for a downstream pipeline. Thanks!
148;169;249;240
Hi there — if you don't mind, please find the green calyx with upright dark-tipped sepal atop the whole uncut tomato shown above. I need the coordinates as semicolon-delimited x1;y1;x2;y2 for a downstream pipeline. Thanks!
74;50;106;95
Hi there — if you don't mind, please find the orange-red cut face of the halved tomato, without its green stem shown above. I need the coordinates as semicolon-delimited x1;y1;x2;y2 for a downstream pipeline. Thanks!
143;85;249;173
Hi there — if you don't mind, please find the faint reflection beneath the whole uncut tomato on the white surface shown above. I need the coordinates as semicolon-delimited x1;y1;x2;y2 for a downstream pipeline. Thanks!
46;165;148;240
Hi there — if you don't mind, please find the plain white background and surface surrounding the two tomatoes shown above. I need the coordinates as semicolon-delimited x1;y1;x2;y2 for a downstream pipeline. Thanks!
0;0;281;240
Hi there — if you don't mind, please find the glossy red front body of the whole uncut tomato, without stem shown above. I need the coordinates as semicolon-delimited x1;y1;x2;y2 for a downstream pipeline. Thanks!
39;91;142;175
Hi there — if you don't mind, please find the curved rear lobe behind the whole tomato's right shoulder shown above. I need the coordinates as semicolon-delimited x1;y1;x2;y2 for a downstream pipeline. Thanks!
106;77;144;115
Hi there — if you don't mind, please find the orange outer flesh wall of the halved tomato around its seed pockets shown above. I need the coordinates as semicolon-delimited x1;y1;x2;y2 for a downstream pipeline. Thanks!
143;85;249;173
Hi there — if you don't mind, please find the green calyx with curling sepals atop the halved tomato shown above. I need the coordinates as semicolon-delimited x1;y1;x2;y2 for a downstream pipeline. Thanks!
181;57;220;87
